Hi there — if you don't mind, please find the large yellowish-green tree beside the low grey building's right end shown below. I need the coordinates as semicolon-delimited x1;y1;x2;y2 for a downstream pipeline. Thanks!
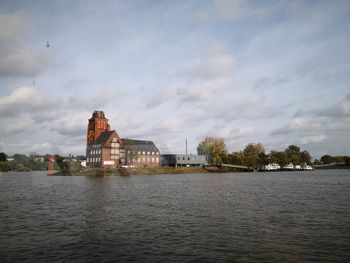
197;137;227;165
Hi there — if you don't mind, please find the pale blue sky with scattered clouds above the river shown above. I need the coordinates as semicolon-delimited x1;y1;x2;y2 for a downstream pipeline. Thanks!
0;0;350;158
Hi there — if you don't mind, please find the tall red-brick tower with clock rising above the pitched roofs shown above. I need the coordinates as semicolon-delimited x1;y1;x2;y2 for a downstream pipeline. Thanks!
86;111;111;145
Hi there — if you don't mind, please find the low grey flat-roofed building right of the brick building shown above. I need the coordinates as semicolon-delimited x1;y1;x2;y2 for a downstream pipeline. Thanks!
161;154;207;167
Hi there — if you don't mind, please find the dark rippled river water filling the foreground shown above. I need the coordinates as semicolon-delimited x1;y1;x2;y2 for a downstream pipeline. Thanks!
0;170;350;262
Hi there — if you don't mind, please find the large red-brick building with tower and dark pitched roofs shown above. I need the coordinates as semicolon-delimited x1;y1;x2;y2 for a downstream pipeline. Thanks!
86;111;160;167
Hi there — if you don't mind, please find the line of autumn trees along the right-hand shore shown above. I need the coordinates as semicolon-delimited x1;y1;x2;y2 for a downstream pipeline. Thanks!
197;137;350;170
